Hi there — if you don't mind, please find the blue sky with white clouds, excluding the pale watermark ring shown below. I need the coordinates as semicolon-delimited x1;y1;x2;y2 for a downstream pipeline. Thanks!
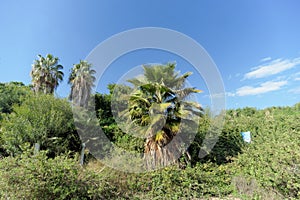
0;0;300;108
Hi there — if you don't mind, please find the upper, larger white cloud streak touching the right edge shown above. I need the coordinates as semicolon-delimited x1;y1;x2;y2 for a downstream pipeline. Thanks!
244;57;300;79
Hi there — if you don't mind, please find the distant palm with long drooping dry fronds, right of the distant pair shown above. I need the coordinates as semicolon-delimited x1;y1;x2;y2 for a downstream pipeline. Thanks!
69;60;96;108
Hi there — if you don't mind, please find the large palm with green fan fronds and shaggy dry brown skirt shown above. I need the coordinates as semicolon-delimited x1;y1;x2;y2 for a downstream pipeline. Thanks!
121;64;202;169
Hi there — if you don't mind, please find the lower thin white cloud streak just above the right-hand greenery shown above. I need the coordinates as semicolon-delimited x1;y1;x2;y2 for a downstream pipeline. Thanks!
236;81;287;96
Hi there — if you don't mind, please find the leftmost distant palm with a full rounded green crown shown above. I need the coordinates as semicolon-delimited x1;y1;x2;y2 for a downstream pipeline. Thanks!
30;54;64;94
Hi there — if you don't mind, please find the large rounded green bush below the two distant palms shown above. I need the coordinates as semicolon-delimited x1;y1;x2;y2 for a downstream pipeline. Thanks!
0;95;80;156
